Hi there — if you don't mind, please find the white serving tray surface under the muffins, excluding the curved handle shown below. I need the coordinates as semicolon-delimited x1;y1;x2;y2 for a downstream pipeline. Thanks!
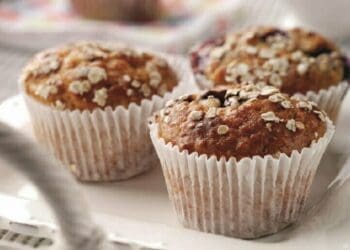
0;94;350;250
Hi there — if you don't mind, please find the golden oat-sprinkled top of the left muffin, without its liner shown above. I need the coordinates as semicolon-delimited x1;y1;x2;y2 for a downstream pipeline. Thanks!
21;42;178;110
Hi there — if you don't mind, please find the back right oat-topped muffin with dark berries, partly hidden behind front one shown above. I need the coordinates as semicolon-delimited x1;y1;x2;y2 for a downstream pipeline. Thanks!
190;27;349;120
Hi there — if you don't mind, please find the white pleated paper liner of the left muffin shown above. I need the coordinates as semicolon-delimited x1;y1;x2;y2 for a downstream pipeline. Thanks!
22;53;195;181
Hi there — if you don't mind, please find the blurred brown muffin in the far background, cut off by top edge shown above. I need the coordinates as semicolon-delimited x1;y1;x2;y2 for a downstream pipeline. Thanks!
71;0;162;22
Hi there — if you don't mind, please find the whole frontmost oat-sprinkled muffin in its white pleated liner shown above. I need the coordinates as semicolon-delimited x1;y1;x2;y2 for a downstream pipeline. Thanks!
150;84;334;239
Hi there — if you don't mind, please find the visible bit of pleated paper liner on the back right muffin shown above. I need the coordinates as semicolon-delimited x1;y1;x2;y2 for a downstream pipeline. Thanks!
298;81;349;122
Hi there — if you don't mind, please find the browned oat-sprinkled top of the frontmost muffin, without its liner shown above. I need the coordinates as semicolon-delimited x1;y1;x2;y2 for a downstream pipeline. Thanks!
154;85;327;160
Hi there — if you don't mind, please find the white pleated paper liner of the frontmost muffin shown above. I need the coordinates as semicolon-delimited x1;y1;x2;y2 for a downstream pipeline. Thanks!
150;119;334;239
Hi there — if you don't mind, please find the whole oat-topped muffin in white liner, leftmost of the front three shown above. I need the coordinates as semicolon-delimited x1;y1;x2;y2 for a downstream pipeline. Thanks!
20;42;188;181
